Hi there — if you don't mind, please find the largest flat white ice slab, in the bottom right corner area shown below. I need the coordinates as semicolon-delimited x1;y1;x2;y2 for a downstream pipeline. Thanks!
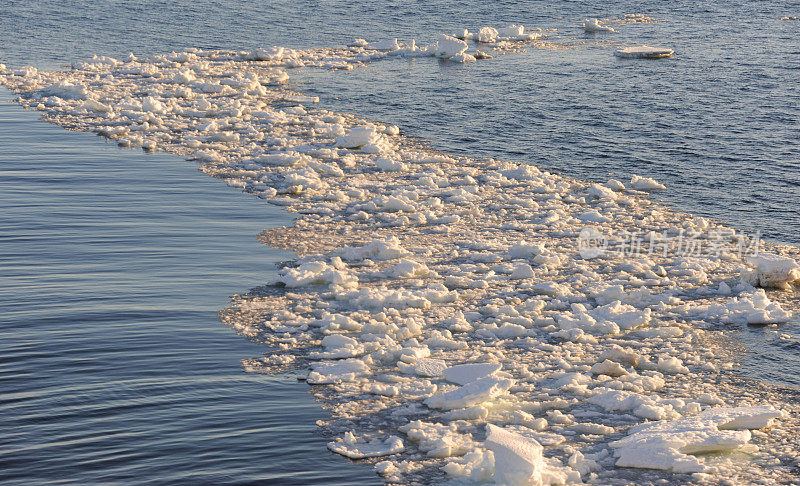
610;405;783;473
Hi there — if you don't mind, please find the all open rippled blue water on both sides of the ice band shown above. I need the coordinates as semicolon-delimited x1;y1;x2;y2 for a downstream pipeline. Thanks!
0;0;800;484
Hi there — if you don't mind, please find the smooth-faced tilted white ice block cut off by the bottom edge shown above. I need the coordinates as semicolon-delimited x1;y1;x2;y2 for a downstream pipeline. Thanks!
485;424;580;485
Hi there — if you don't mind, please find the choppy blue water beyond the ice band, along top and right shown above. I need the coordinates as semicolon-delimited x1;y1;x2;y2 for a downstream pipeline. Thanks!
0;0;800;244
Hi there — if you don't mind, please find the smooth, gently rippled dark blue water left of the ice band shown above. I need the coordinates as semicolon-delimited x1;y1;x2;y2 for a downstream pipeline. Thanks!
0;91;375;485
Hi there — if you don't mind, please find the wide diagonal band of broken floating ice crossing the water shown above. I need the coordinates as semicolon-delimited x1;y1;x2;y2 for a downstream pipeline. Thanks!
2;33;798;484
